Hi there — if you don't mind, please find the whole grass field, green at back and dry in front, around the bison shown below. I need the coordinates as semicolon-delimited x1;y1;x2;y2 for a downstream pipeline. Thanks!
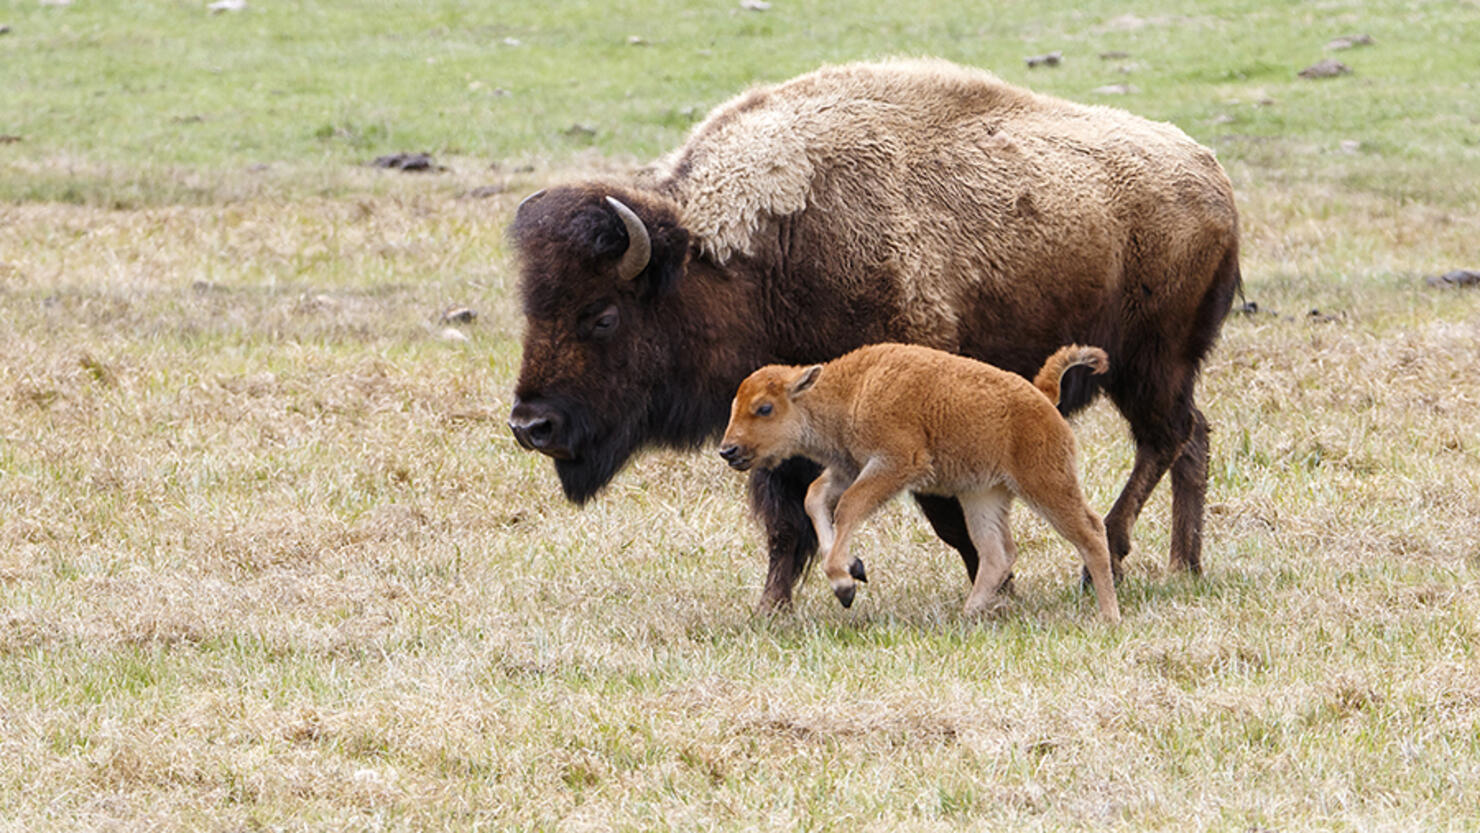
0;0;1480;832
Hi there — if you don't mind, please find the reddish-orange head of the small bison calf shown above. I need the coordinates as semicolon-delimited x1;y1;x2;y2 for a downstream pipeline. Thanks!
719;364;823;472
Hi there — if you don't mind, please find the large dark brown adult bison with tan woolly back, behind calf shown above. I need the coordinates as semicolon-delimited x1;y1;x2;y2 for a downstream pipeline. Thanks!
509;61;1240;607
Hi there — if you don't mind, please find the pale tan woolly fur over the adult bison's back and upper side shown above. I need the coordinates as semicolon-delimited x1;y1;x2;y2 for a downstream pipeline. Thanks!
639;58;1237;349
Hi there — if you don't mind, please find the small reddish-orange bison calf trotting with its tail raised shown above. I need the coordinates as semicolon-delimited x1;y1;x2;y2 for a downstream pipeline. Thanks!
719;345;1120;621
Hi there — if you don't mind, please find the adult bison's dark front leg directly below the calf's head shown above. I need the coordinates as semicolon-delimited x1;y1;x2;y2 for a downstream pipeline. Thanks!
750;457;821;613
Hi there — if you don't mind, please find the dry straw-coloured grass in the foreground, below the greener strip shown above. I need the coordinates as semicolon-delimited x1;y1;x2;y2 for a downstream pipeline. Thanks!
0;164;1480;830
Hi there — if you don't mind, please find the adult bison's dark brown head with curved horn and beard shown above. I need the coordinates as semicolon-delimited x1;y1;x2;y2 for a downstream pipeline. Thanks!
509;185;701;503
